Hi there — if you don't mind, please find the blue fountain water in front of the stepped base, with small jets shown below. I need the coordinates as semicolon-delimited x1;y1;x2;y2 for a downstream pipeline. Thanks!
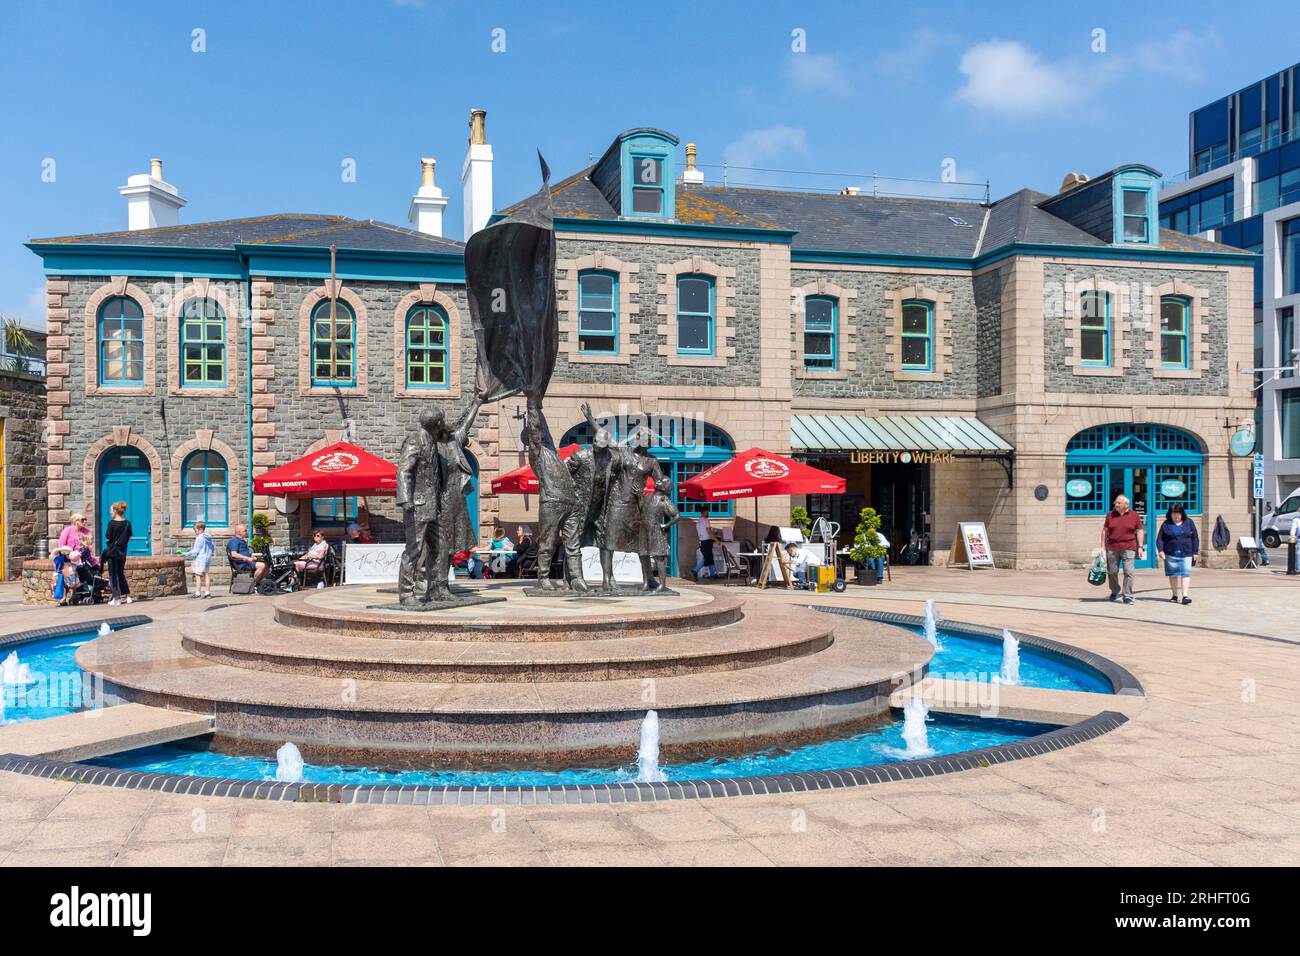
87;714;1053;787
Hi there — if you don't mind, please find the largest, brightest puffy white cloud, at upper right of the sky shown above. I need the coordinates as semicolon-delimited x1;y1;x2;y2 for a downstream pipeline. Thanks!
957;40;1091;113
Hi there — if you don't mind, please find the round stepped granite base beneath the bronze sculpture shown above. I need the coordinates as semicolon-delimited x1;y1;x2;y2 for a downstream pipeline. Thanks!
77;584;932;769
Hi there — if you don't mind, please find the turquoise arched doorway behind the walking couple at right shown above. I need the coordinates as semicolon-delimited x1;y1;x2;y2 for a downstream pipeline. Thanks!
1065;421;1204;567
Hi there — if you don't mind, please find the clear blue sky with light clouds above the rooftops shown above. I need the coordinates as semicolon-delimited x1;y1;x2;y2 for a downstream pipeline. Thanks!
0;0;1300;324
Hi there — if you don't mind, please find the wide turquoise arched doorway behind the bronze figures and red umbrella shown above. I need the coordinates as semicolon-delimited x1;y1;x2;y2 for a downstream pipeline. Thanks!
559;415;736;575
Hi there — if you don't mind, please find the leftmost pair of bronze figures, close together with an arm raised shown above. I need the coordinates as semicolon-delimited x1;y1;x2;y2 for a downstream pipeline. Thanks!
397;395;482;607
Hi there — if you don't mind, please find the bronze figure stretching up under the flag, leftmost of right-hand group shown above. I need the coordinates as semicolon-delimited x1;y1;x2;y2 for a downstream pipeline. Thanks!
524;392;588;591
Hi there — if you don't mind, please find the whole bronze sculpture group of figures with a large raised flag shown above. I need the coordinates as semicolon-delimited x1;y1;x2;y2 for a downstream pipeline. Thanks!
397;156;677;609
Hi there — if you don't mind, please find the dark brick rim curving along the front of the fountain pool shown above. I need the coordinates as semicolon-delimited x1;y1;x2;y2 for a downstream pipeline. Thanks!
0;710;1128;806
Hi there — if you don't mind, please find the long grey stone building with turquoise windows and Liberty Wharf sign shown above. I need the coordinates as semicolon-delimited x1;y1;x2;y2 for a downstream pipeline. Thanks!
30;137;1252;567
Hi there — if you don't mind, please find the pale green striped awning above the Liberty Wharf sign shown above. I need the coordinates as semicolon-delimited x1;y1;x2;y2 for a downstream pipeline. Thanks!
790;415;1014;455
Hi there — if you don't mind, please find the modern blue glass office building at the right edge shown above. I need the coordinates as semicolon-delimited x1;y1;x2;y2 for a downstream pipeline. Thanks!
1160;64;1300;507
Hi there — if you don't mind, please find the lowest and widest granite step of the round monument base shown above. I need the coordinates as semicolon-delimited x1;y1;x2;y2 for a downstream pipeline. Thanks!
77;606;933;762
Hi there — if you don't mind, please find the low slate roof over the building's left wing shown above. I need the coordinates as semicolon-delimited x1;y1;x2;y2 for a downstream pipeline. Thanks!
33;213;464;252
